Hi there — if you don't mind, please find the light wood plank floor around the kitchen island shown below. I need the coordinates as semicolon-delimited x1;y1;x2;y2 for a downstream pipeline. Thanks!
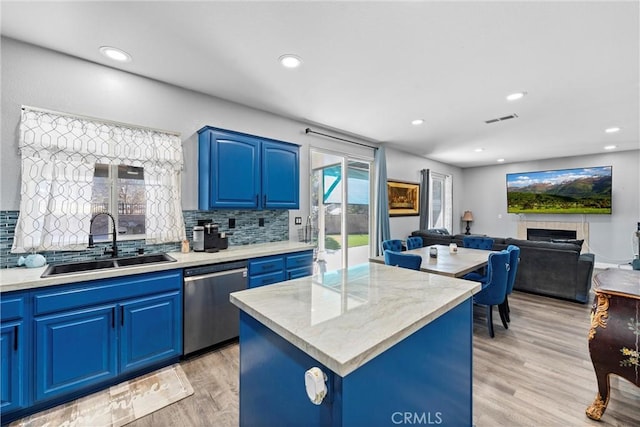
128;292;640;427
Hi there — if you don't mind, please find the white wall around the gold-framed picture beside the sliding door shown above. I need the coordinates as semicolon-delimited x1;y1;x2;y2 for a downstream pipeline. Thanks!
386;148;466;239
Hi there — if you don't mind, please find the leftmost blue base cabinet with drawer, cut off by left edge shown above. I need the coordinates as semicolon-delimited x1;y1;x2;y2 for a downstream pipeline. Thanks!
0;293;30;415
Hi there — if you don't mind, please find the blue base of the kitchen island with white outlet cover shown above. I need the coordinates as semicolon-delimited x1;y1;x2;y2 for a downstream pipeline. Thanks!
240;299;473;427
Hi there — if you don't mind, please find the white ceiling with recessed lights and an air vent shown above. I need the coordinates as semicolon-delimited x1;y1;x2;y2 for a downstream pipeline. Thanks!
1;0;640;167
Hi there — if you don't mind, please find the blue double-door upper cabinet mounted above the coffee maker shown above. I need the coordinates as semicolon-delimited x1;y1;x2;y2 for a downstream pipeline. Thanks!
198;126;300;210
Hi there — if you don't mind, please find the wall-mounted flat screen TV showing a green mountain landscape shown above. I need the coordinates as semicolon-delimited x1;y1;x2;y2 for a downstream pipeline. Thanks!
507;166;612;214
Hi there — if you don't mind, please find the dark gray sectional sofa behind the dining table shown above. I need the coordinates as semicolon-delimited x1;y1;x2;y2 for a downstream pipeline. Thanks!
411;229;595;303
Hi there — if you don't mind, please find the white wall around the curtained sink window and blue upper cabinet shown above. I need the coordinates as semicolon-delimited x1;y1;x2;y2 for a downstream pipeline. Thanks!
0;37;371;238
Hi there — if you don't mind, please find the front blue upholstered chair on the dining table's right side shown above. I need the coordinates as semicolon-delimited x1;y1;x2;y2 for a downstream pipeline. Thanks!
473;250;509;338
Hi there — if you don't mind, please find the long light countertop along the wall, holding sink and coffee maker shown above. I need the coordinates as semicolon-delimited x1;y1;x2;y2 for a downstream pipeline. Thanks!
0;241;313;292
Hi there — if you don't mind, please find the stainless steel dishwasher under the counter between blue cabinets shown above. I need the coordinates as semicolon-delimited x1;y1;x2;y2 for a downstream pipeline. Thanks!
182;260;247;355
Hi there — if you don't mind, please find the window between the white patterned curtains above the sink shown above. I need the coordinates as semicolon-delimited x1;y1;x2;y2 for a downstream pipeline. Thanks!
91;164;147;240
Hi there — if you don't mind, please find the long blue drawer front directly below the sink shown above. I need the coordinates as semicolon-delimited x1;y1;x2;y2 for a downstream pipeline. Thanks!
33;270;182;316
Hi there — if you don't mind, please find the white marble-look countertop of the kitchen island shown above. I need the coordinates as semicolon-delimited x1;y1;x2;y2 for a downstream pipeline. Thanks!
230;263;481;377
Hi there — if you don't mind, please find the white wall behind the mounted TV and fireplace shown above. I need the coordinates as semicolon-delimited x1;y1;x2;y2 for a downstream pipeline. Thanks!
463;150;640;264
